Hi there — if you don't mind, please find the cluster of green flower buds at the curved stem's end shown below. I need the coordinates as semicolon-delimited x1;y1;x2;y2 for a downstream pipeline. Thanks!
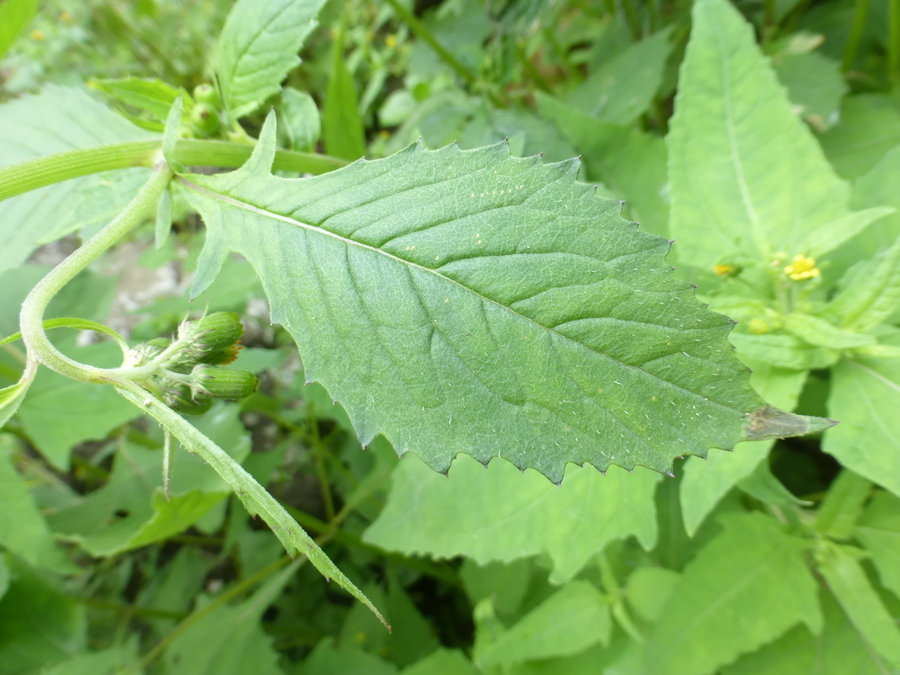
127;312;256;415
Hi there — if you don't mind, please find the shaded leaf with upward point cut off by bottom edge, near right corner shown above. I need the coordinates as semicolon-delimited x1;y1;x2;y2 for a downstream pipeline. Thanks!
722;589;888;675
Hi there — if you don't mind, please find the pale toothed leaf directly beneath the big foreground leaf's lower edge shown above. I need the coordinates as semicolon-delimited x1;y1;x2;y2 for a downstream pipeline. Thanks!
364;455;660;583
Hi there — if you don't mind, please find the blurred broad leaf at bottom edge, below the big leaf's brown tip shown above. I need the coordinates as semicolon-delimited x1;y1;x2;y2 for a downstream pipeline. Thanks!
645;513;822;675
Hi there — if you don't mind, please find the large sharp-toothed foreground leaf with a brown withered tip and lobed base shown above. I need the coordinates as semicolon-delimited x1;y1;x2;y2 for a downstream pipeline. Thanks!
180;115;818;482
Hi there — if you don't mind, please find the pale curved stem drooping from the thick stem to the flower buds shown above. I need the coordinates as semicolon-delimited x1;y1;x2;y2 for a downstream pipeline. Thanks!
19;162;172;384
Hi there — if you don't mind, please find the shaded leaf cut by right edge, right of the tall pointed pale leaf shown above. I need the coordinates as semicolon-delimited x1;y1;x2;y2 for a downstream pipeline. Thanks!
821;94;900;180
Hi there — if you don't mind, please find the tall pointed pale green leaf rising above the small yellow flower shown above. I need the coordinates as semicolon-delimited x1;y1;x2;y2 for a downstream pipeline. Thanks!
667;0;884;269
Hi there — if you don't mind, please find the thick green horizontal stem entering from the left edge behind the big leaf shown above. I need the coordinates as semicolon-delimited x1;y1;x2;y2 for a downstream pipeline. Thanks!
0;139;347;201
